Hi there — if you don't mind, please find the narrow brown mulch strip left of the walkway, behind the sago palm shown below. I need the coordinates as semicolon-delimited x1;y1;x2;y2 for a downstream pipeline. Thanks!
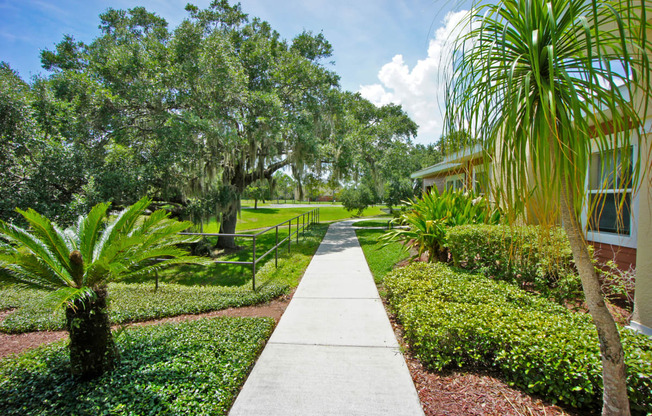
0;294;292;359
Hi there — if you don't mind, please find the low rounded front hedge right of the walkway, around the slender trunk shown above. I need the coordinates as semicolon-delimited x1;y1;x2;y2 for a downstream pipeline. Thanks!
385;263;652;412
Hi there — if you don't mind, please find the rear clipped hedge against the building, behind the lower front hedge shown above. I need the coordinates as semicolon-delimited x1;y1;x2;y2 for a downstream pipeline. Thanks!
448;225;582;301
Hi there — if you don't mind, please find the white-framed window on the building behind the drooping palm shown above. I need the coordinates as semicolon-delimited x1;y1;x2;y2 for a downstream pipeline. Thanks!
583;141;638;247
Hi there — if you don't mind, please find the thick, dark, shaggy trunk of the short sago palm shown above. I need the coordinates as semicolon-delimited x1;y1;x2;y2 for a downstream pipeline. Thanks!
66;286;119;380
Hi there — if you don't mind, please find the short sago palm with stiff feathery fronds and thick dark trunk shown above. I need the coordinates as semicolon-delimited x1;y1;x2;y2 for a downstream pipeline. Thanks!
0;198;201;379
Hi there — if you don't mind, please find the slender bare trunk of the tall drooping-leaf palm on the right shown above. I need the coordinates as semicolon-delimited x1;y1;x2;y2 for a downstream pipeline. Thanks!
561;183;630;415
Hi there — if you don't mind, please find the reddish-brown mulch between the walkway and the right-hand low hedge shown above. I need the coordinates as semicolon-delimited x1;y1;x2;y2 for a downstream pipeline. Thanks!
383;299;587;416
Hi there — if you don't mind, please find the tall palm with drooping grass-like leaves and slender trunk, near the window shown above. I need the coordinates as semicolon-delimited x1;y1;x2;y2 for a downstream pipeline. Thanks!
446;0;651;415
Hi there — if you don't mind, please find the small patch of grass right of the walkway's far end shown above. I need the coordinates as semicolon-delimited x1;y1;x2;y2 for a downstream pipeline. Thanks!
355;229;410;284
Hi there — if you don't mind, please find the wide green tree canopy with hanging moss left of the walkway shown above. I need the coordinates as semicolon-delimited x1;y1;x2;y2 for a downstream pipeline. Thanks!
0;0;417;234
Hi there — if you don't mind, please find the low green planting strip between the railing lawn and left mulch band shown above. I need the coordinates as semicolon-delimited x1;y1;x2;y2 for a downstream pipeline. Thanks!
0;283;289;333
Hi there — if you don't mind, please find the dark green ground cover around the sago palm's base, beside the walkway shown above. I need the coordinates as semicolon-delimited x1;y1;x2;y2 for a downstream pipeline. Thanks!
0;318;274;416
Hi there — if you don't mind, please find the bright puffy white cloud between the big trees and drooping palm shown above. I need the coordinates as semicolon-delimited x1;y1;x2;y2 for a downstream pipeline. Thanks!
359;10;468;143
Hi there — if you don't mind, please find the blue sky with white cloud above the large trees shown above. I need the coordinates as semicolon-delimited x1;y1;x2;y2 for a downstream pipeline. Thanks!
0;0;472;143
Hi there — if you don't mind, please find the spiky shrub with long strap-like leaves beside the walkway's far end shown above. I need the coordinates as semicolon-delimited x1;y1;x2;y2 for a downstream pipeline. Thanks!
384;187;500;261
